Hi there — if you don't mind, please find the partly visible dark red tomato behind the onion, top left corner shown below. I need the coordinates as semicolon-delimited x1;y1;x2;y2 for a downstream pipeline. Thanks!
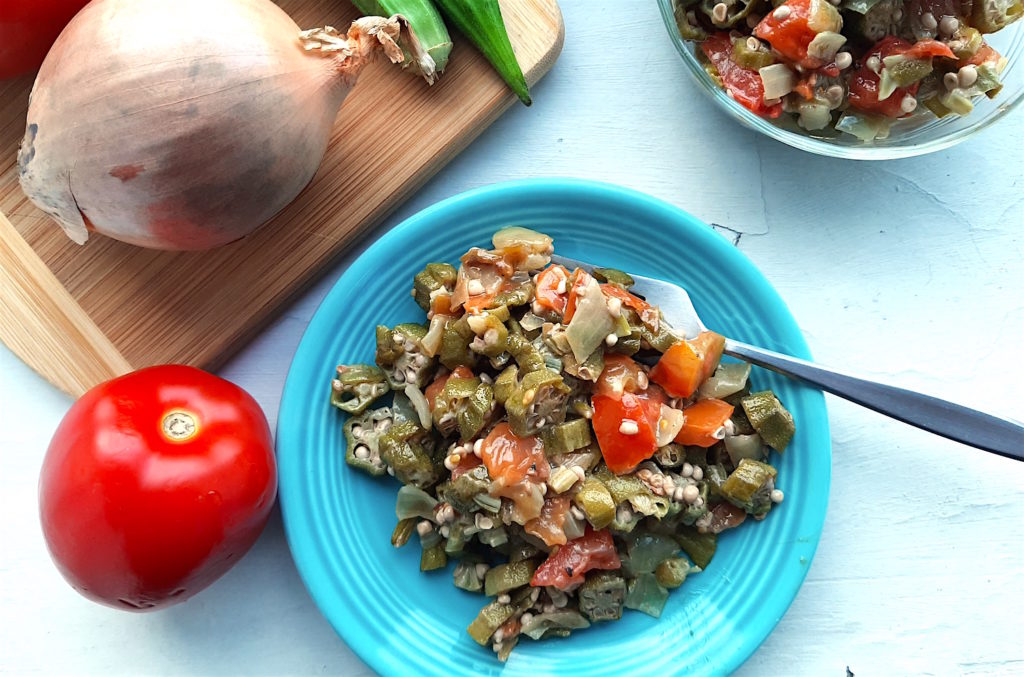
0;0;89;80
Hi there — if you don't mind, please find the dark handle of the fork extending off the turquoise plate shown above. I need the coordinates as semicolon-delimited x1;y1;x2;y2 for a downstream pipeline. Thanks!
725;340;1024;461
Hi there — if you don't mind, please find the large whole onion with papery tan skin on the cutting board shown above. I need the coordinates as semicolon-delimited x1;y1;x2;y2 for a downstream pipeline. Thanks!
18;0;419;250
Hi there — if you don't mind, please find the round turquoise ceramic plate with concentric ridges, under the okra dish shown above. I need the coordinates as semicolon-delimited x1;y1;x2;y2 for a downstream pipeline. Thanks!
278;179;830;677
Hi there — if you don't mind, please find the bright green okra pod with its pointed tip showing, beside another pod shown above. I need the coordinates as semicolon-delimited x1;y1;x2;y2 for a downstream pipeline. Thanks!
434;0;532;105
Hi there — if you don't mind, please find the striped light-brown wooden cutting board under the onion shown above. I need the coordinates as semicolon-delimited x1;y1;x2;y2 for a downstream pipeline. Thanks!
0;0;563;396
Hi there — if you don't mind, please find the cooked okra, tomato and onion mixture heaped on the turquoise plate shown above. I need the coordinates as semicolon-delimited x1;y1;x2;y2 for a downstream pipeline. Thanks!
331;227;796;661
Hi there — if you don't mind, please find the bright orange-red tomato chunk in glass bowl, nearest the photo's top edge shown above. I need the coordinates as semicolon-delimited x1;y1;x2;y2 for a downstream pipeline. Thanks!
754;0;843;70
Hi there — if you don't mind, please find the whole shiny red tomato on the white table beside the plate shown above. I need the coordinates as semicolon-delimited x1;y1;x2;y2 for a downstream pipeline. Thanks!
39;365;278;610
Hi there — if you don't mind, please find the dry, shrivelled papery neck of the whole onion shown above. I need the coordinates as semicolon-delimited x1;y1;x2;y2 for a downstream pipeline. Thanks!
299;14;436;86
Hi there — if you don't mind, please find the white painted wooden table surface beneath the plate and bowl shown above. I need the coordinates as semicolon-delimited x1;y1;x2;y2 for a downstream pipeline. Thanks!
0;0;1024;677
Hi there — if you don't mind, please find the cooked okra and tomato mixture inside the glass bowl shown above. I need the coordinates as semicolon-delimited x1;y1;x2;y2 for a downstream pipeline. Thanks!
672;0;1024;141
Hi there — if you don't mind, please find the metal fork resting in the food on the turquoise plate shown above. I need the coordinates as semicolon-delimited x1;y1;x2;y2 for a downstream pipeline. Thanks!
551;256;1024;461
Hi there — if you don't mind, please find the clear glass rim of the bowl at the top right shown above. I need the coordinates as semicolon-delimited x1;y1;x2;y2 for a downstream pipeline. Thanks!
657;0;1024;160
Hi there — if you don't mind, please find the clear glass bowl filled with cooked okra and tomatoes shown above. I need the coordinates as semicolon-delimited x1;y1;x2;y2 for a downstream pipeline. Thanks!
658;0;1024;160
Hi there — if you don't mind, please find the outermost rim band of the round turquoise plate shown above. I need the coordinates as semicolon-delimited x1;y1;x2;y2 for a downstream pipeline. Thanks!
275;177;831;674
